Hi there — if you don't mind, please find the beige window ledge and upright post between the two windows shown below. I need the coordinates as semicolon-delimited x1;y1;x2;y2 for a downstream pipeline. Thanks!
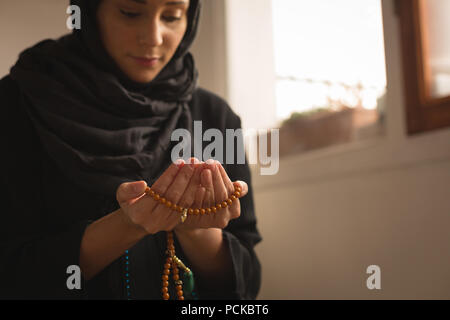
251;0;450;192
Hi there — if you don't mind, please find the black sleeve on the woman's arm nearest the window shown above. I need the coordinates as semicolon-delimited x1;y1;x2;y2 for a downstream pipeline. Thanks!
186;90;262;300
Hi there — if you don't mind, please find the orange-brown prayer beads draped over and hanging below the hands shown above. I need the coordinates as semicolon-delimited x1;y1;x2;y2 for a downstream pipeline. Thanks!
145;184;241;300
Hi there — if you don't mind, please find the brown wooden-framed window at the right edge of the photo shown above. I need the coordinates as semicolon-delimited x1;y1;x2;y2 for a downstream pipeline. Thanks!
396;0;450;134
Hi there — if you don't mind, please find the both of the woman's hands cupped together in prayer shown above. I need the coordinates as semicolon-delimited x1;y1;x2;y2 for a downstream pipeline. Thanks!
116;158;248;234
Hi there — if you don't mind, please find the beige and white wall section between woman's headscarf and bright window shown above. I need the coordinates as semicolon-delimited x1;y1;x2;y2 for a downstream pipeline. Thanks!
192;0;276;129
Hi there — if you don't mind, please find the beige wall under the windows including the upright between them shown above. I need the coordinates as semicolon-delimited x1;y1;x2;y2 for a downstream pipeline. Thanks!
253;0;450;299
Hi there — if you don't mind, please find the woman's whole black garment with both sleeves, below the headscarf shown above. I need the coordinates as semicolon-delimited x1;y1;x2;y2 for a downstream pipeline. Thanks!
0;77;261;299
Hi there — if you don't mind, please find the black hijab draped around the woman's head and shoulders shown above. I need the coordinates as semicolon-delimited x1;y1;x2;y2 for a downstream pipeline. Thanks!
11;0;201;196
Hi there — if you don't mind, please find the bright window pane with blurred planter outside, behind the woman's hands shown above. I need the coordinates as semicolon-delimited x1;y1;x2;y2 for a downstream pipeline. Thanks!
272;0;386;157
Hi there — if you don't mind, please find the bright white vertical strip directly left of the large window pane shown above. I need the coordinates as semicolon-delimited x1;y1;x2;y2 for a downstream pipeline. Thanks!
225;0;276;129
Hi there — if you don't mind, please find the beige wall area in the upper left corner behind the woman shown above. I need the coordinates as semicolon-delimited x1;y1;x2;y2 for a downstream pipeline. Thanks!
0;0;69;78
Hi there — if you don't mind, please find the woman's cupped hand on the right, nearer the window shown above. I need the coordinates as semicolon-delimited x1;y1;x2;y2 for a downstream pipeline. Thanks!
175;160;248;231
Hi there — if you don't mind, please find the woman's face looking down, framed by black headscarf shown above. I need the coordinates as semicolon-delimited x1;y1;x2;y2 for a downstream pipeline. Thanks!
97;0;189;83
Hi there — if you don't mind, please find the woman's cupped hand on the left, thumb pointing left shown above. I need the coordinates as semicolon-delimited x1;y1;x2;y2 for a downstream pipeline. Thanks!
116;158;200;234
